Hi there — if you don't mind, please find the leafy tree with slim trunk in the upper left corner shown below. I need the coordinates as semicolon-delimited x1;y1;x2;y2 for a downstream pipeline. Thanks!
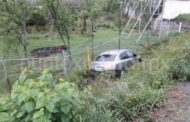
0;0;32;66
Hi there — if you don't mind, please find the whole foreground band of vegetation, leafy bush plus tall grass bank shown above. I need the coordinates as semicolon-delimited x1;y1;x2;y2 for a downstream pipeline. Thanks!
0;34;190;122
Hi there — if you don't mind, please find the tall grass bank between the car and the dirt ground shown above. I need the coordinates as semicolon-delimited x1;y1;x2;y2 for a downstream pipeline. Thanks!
89;34;190;122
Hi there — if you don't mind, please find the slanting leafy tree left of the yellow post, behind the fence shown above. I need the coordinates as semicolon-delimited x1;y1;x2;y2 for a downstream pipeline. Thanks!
44;0;73;59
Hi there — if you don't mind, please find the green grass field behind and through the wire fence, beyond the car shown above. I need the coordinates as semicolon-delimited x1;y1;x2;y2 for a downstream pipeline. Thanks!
0;29;163;93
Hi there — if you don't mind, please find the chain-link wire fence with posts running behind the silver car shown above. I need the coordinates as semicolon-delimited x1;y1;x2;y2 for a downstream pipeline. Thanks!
0;0;184;90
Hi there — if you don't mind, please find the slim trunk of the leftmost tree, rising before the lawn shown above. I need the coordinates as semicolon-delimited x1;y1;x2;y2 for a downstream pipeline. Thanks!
22;22;28;67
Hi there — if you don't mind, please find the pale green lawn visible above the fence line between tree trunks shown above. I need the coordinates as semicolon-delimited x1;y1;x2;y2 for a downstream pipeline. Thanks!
0;29;118;57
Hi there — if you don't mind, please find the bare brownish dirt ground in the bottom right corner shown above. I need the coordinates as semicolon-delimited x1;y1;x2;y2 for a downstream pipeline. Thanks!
154;82;190;122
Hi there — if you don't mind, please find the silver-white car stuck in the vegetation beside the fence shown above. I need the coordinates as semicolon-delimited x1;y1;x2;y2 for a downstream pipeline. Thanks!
90;49;142;77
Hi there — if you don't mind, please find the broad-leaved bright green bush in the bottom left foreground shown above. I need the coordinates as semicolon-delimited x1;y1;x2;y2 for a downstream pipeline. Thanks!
0;71;110;122
